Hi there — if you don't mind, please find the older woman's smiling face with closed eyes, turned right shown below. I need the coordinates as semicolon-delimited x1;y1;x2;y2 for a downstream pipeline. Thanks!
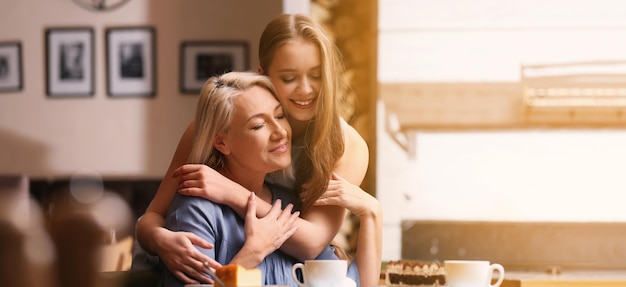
217;86;291;176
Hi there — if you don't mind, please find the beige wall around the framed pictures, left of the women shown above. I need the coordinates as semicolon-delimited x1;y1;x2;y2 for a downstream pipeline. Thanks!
0;0;282;178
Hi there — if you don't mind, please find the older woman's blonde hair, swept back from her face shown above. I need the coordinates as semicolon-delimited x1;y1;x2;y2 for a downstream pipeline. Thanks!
189;72;278;170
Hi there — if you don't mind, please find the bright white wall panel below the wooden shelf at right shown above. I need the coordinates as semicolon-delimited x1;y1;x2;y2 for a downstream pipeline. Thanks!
401;130;626;222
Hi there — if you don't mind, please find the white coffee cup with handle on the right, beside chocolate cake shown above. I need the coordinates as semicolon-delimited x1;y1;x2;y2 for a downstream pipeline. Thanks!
443;260;504;287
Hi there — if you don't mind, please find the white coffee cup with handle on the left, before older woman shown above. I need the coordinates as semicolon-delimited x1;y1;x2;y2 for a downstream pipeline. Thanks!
291;260;348;287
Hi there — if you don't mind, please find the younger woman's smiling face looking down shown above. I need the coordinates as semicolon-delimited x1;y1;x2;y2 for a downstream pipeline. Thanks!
267;38;322;121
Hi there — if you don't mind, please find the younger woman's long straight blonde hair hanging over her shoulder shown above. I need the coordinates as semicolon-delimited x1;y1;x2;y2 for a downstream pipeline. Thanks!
259;14;347;214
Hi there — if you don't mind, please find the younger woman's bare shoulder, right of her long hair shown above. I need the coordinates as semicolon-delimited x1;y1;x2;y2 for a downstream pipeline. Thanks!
335;122;369;185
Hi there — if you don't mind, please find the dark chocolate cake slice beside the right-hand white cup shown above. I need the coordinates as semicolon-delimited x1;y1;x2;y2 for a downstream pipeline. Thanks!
385;260;446;286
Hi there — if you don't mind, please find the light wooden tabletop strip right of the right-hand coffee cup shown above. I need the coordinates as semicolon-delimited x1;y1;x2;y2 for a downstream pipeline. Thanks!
501;270;626;287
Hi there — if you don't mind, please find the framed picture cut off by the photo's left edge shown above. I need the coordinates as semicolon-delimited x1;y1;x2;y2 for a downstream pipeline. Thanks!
0;42;23;92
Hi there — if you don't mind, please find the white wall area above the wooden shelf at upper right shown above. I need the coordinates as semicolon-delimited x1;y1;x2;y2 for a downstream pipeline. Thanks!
378;0;626;82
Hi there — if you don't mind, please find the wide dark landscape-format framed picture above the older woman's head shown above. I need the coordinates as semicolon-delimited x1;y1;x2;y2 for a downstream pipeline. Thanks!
180;41;249;94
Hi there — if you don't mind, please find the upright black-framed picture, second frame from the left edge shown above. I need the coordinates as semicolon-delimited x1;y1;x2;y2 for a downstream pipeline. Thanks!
46;28;94;98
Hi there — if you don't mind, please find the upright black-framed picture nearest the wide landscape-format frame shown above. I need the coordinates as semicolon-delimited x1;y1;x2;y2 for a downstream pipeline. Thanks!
106;27;156;98
